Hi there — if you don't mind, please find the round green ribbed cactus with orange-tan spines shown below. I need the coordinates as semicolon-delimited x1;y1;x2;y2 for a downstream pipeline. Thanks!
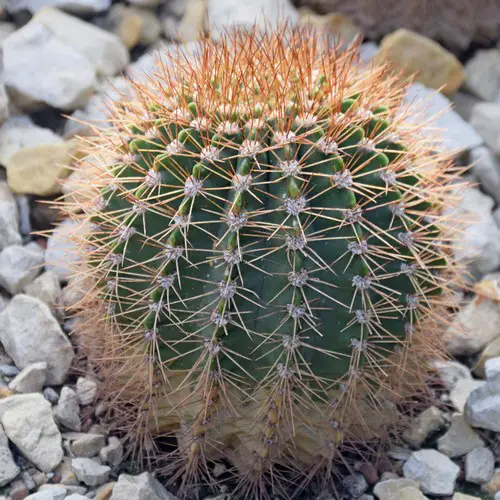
66;30;457;498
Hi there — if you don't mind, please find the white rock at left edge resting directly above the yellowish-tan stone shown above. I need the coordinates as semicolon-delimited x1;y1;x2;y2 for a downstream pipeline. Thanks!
0;116;64;165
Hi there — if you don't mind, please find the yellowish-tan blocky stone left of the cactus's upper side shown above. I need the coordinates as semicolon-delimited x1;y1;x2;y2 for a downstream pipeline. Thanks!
7;142;73;196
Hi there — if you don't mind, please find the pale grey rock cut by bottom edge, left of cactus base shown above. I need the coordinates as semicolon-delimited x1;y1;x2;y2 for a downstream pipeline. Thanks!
110;472;177;500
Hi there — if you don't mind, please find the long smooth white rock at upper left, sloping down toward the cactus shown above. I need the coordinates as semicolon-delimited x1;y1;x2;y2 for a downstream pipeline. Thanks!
33;8;129;76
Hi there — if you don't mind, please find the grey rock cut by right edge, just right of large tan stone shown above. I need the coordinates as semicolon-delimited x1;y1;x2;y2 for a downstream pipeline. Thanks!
464;49;500;101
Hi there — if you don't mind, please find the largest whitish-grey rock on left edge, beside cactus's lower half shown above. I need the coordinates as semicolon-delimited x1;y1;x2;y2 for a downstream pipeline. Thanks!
0;294;74;385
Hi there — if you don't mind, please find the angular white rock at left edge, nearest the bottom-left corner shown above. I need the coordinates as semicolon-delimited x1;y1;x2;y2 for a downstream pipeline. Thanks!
0;393;63;472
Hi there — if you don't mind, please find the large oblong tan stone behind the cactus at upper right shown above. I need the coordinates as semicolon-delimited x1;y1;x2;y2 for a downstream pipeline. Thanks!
378;29;464;94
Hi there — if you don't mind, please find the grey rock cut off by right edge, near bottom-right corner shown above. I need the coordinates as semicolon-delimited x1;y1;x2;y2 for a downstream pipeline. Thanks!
464;380;500;432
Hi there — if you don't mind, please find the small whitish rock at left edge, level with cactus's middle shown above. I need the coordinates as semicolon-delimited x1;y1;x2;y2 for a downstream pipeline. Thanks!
0;242;44;295
